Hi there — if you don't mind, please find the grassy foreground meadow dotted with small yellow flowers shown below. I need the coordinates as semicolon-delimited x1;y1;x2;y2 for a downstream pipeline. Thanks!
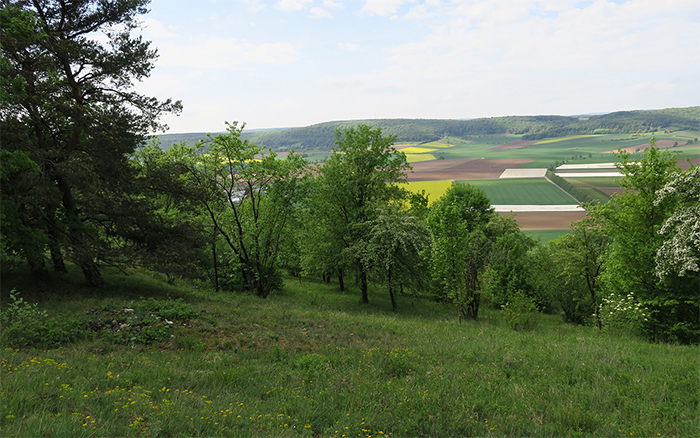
0;271;700;437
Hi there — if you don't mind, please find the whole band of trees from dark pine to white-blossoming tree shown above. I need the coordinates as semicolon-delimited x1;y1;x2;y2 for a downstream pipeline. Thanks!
0;0;700;343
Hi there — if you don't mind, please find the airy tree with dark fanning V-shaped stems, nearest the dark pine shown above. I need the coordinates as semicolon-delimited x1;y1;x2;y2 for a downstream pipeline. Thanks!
168;123;306;298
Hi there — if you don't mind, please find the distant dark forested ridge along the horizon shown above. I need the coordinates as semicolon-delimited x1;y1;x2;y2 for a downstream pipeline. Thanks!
160;106;700;152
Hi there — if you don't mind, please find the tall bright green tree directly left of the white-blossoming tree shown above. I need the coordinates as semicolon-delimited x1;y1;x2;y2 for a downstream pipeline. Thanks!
592;141;700;343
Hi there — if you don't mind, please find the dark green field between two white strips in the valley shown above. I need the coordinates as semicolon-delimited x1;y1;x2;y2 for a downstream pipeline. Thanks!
460;178;576;205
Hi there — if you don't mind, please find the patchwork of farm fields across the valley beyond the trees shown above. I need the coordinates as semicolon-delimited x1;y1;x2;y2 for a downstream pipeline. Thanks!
402;131;700;236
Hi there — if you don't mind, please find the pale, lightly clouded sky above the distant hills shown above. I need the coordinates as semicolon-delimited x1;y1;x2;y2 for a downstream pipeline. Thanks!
136;0;700;133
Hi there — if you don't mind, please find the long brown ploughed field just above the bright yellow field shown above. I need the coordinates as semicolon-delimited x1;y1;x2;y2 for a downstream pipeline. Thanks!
408;158;533;181
